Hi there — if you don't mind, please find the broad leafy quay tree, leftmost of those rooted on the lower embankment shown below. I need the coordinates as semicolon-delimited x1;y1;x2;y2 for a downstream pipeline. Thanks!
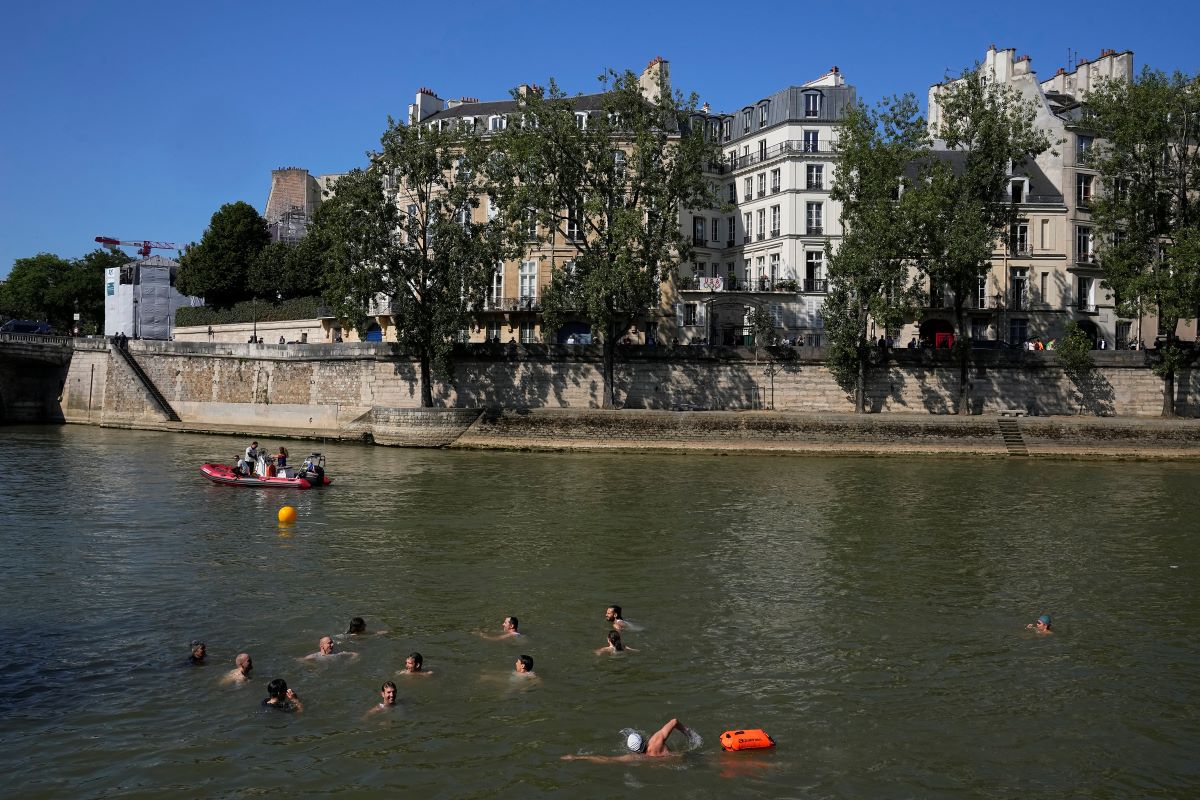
308;119;517;408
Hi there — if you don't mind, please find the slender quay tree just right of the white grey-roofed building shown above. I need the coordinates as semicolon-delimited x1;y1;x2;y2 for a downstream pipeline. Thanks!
821;95;928;414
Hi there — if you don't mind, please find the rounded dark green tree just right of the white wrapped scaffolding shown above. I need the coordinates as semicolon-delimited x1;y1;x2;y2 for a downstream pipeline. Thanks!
175;200;271;308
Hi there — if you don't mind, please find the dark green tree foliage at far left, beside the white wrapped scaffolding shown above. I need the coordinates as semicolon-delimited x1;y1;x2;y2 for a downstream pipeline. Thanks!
0;249;132;333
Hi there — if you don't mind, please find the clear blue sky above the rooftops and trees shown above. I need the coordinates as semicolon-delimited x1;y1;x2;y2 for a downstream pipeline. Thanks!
0;0;1200;276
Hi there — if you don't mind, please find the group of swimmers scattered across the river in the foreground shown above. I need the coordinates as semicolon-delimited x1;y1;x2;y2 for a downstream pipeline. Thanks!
188;604;1054;763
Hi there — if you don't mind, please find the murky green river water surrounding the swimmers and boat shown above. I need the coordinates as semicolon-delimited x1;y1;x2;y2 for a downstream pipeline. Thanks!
0;426;1200;800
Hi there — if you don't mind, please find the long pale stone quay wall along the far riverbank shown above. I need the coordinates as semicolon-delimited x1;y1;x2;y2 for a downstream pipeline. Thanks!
44;342;1200;452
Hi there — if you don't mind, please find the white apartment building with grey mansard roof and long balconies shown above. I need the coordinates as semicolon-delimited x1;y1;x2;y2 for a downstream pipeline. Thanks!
664;67;856;345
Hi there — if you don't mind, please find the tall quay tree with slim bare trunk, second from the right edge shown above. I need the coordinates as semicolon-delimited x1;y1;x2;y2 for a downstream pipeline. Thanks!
913;65;1051;414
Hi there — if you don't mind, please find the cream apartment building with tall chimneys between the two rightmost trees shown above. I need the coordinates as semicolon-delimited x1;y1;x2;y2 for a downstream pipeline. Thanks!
912;46;1153;348
